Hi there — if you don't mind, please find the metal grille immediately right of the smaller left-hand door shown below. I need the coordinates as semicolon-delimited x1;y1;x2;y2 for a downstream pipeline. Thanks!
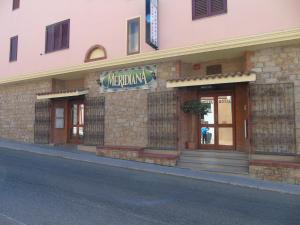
84;96;105;145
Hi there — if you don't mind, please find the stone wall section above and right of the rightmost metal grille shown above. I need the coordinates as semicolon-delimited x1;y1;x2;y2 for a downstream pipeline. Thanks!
249;45;300;154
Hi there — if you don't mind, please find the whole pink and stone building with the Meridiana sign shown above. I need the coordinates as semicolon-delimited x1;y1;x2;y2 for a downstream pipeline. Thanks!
0;0;300;183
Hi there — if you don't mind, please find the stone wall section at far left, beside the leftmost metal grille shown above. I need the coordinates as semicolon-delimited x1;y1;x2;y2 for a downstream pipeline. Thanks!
0;80;52;143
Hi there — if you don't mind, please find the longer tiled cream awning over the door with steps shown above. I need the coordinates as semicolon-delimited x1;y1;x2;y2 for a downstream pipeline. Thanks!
167;72;256;88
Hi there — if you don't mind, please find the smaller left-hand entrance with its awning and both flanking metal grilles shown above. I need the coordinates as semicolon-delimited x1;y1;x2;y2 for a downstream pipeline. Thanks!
34;86;105;146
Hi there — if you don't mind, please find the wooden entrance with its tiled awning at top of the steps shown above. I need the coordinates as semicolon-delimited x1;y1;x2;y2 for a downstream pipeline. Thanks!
167;72;256;152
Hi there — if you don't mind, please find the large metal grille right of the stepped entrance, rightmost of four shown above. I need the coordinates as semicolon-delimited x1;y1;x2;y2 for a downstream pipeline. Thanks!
250;83;295;154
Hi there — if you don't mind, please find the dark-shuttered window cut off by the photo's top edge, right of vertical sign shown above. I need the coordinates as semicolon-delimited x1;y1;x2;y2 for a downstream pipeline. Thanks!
192;0;227;20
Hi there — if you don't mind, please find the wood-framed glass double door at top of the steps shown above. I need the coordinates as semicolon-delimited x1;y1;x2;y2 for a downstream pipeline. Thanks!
198;92;235;150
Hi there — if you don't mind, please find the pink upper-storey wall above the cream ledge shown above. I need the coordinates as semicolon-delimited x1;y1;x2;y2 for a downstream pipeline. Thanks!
0;0;300;79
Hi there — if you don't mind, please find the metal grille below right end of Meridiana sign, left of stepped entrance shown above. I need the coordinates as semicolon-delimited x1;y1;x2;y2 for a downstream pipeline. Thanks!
148;91;178;150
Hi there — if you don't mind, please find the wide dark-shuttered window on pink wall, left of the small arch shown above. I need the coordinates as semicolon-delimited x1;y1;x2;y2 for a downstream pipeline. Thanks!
45;20;70;53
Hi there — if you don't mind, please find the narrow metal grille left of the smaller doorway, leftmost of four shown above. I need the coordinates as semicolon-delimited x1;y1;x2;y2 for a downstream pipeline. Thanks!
34;101;50;144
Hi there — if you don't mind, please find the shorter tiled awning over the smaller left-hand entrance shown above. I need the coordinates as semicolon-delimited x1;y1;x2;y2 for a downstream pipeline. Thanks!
36;89;89;100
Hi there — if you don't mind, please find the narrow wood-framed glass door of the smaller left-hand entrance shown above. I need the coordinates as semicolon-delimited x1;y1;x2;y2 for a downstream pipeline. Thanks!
69;101;84;144
